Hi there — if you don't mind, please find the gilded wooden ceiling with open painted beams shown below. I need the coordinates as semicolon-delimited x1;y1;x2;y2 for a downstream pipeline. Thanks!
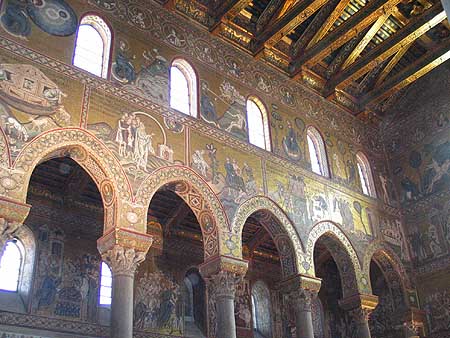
159;0;450;118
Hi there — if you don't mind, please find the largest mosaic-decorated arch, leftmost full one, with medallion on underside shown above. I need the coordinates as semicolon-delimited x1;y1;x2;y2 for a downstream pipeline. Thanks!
11;128;132;230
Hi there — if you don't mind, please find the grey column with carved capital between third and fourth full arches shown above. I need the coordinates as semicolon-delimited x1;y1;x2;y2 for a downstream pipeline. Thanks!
281;275;321;338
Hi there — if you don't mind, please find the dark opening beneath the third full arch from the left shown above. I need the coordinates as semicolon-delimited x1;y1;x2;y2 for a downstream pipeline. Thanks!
243;211;296;338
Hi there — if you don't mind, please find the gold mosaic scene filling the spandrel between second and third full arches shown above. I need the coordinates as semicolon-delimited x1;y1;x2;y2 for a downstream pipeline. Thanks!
190;134;263;217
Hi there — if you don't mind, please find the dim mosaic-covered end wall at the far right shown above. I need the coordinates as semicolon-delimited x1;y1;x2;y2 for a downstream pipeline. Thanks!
383;66;450;337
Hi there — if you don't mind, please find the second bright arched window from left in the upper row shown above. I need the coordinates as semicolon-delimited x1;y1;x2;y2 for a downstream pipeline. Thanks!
170;59;198;117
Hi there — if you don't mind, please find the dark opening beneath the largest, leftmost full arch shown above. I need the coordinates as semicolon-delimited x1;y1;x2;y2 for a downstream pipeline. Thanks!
2;157;106;324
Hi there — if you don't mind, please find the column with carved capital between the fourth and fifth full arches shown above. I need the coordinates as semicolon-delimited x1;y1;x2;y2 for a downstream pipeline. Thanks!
339;294;378;338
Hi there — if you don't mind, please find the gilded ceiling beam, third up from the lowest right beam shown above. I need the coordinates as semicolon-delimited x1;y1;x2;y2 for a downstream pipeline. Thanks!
289;0;402;76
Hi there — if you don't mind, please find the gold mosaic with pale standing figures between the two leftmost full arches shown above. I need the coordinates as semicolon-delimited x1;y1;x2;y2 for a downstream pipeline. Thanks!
88;92;184;188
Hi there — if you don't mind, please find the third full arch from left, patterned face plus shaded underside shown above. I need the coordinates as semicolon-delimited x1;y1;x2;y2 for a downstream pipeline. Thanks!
232;196;305;274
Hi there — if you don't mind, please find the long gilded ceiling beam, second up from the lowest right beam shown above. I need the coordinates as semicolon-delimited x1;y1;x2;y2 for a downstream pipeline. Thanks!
324;4;446;96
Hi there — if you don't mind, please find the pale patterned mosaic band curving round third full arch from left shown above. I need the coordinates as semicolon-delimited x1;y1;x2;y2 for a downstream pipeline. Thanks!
232;196;307;273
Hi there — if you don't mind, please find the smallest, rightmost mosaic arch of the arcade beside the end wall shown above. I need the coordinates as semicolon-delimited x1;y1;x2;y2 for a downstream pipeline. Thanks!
363;240;411;293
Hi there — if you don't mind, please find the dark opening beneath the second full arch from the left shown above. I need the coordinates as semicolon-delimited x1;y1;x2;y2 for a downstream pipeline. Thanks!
134;184;207;337
